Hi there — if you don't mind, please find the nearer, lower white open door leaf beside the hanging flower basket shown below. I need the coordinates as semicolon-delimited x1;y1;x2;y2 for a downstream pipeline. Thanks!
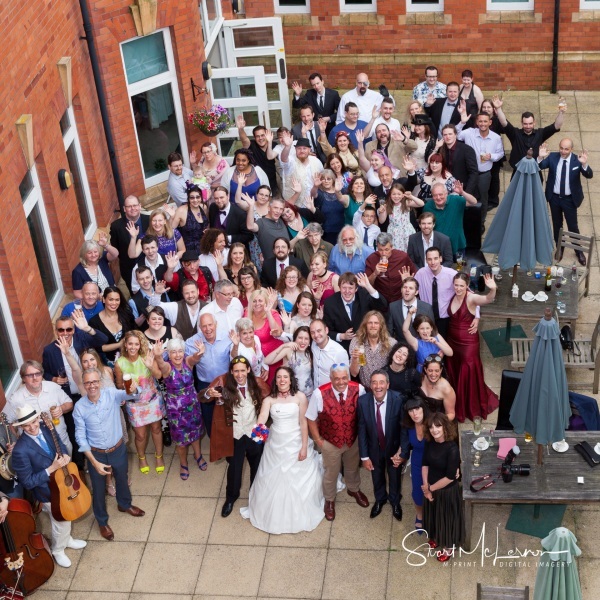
208;67;270;164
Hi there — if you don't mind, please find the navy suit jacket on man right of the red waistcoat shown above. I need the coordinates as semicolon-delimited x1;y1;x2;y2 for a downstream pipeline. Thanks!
358;390;408;462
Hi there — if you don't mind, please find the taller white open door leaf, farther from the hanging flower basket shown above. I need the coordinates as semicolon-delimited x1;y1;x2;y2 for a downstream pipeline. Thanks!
223;17;291;129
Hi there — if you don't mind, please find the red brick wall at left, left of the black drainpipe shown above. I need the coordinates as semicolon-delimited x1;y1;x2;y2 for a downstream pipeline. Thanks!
0;0;116;403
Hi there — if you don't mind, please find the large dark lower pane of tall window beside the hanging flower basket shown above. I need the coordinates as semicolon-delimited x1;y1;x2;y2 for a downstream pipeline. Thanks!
131;83;181;179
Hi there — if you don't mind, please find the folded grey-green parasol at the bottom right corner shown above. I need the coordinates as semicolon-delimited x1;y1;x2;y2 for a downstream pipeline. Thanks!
533;527;583;600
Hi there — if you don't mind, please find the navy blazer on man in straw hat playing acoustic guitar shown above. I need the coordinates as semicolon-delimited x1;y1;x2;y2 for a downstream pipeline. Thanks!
12;424;69;502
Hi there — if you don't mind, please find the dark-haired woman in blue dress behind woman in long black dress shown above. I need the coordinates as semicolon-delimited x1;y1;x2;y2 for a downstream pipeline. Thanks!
402;396;429;535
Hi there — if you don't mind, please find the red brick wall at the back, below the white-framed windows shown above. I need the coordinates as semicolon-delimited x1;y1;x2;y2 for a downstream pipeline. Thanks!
245;0;600;90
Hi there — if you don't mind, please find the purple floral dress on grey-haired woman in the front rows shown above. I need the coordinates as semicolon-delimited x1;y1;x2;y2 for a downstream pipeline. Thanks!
164;361;204;446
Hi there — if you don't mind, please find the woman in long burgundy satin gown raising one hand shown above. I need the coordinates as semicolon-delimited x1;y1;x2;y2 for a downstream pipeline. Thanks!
447;273;498;423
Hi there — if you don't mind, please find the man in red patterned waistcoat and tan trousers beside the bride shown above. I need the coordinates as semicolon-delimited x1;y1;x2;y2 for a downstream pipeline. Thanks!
306;363;369;521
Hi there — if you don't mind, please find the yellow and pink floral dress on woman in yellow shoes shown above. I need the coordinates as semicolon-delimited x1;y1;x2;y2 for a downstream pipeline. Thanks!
115;356;164;427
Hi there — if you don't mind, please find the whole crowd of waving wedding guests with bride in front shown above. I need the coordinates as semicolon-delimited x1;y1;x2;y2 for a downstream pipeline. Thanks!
0;66;592;567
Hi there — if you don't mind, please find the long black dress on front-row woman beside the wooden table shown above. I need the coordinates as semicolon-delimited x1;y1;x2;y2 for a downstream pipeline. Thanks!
423;442;465;549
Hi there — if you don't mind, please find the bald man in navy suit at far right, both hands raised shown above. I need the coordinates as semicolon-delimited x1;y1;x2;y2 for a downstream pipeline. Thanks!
538;138;594;267
